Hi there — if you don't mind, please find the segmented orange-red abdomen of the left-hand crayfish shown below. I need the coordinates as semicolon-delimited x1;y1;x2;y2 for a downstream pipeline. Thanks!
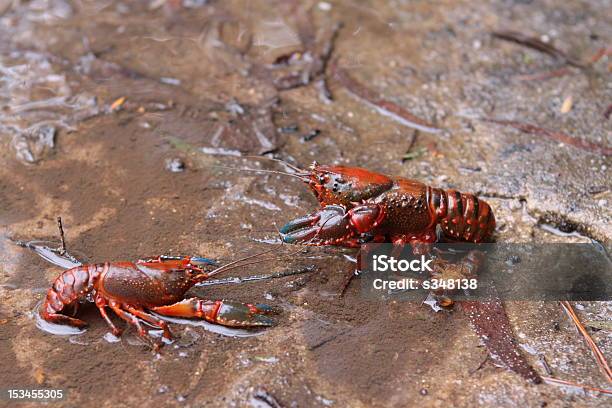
41;264;108;315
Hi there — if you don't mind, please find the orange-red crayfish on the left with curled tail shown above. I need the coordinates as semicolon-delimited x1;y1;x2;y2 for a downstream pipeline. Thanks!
40;256;274;348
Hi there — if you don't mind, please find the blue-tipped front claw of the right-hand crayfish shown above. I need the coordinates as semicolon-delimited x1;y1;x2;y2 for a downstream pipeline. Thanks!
280;205;352;245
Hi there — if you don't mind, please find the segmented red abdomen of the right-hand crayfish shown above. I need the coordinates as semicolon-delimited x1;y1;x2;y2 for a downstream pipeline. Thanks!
428;188;495;242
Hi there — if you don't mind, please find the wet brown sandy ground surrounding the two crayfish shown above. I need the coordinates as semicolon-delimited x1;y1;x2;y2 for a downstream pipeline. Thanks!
0;1;612;407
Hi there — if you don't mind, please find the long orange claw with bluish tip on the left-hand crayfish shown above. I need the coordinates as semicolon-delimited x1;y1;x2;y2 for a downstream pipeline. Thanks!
151;298;274;327
